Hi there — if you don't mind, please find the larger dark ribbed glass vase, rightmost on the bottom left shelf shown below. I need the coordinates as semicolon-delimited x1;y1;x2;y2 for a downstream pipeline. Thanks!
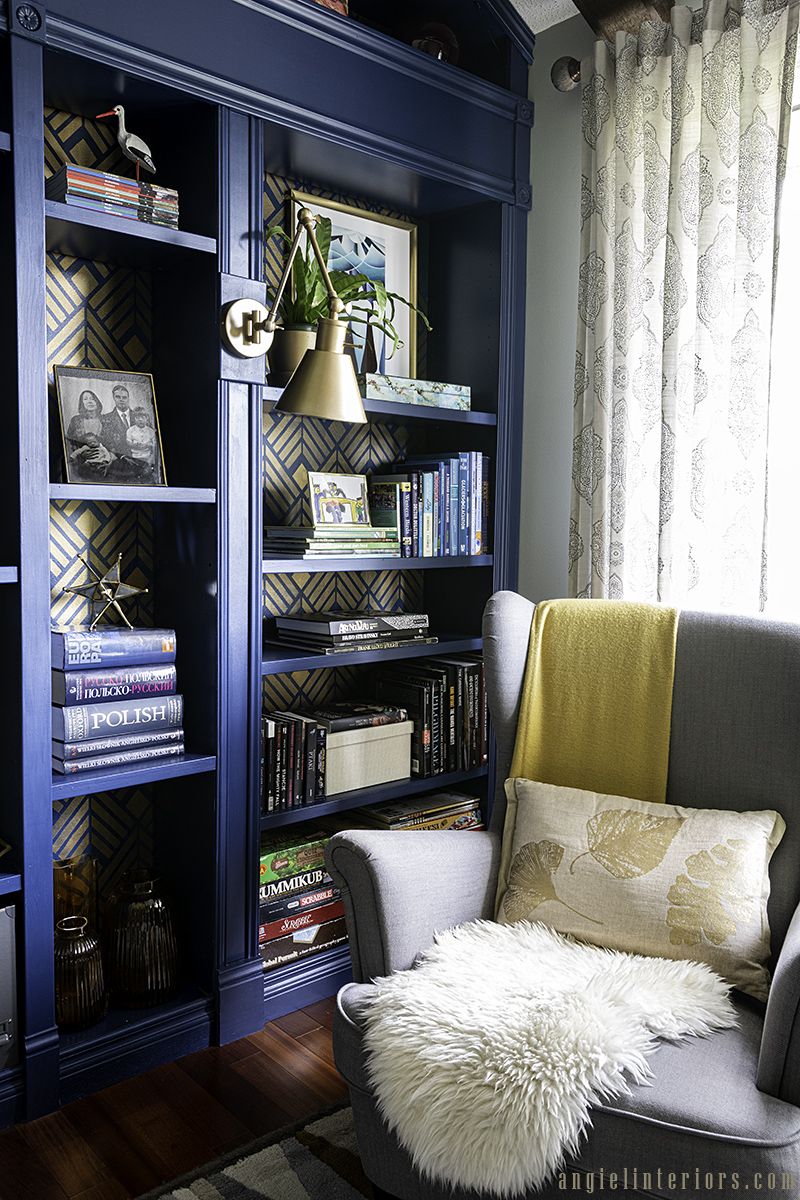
103;868;180;1008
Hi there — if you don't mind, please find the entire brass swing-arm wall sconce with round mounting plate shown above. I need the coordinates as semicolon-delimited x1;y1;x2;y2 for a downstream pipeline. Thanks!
221;209;367;425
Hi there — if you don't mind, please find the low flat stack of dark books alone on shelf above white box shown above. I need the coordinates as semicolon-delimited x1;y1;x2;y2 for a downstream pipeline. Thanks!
275;608;438;654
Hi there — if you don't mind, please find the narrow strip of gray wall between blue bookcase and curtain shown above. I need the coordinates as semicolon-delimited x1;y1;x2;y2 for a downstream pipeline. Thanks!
519;17;595;601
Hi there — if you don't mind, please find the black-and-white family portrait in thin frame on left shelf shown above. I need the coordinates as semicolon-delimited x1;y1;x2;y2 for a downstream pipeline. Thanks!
54;364;167;487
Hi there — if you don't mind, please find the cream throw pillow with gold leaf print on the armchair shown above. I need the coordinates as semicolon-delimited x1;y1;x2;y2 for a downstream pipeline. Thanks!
497;779;786;1000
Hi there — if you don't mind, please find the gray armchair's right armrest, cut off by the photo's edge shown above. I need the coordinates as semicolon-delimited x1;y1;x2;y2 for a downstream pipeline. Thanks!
756;906;800;1105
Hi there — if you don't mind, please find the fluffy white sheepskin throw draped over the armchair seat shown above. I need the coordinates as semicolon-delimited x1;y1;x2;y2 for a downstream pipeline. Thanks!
363;920;735;1196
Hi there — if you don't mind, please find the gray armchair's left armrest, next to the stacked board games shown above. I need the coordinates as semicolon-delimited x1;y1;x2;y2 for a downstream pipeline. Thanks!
325;829;500;983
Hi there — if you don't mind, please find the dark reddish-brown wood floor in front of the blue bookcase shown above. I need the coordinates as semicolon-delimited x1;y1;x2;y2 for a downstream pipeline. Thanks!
0;997;347;1200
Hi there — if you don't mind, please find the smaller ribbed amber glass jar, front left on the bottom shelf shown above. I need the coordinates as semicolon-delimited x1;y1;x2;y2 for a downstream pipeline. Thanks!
54;917;108;1031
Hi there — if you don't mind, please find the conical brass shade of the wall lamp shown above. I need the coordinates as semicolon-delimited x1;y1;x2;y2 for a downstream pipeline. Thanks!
275;317;367;425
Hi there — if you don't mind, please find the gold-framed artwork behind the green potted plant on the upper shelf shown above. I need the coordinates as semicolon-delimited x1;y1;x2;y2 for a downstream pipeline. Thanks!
288;191;417;379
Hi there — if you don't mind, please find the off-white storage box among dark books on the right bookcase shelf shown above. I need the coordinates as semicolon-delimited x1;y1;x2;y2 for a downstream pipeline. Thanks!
325;721;414;796
